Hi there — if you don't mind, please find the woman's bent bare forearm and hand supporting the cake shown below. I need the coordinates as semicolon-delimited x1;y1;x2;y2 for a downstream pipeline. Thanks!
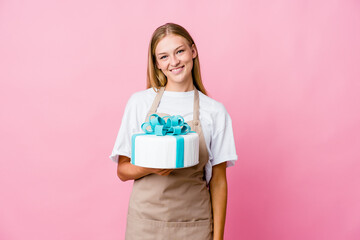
117;156;173;182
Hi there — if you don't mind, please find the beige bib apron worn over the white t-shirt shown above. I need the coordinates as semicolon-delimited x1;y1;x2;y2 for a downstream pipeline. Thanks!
125;87;213;240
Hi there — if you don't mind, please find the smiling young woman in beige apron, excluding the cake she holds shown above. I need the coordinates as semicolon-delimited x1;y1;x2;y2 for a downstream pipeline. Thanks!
110;23;237;240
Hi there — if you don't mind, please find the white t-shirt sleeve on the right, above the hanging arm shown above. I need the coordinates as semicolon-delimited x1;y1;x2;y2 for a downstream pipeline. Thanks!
210;104;238;167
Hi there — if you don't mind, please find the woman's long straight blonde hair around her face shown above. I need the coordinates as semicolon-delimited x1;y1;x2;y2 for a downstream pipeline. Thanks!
147;23;207;95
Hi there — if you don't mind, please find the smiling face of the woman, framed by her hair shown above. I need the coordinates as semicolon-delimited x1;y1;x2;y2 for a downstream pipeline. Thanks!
155;34;197;84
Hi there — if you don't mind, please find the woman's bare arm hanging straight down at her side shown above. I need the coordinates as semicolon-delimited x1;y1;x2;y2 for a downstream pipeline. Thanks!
210;162;227;240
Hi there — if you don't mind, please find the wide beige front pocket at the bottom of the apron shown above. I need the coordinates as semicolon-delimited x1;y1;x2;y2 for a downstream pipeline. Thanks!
125;215;212;240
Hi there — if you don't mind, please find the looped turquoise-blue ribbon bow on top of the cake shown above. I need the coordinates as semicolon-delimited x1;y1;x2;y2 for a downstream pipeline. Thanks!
141;114;191;136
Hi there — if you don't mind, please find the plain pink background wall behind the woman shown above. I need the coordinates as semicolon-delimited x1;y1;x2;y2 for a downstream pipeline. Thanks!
0;0;360;240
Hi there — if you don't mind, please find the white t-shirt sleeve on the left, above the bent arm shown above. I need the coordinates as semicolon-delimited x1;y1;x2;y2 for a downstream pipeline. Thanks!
109;96;138;163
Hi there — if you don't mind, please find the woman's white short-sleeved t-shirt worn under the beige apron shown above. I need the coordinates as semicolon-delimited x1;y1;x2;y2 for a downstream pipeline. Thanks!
109;88;237;183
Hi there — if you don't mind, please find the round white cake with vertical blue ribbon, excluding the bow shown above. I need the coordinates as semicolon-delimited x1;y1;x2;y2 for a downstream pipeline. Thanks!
131;132;199;169
